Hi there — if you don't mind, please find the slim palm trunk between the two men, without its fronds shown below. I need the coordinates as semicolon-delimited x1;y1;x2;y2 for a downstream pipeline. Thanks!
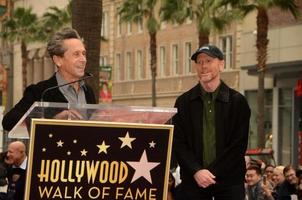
149;32;157;106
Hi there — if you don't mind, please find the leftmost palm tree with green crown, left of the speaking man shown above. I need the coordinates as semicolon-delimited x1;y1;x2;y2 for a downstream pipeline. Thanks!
0;8;40;89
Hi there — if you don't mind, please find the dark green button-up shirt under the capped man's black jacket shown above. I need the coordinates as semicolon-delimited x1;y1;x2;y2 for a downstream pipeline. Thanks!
201;87;219;167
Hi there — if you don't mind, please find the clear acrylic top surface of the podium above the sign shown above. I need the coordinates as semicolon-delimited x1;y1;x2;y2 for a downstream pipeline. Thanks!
9;102;177;139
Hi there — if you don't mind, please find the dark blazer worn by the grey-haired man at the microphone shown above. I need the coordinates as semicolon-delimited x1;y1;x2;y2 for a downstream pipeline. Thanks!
2;74;96;131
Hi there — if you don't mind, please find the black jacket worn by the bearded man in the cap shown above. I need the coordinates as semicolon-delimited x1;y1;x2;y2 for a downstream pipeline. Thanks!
172;82;251;185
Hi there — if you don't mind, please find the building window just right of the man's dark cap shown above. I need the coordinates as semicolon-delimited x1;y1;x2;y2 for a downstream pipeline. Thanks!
220;35;235;69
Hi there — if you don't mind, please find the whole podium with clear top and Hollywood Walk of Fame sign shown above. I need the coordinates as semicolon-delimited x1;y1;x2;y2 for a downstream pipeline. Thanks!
9;102;177;200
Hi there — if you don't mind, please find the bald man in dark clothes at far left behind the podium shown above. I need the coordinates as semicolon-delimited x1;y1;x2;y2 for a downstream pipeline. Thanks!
7;141;27;200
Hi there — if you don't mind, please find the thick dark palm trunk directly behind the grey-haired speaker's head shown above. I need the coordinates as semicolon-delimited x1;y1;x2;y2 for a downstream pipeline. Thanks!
71;0;102;100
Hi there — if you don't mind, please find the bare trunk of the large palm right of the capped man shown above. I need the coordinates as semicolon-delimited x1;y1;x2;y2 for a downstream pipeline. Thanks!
256;7;269;148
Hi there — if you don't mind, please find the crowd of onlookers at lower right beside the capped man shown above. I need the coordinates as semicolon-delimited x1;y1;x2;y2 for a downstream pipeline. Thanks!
245;161;302;200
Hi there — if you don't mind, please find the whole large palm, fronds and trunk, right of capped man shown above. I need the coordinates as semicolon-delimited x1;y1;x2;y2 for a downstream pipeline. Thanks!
226;0;299;148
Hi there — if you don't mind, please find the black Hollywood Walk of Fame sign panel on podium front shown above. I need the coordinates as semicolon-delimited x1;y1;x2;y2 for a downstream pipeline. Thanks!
26;119;173;200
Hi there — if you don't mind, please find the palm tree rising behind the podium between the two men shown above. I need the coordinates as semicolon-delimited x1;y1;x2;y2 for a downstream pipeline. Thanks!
119;0;159;106
